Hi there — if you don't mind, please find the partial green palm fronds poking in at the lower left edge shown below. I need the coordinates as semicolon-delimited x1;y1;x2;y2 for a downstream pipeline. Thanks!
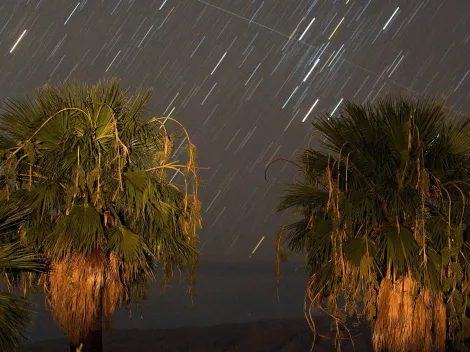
0;204;45;352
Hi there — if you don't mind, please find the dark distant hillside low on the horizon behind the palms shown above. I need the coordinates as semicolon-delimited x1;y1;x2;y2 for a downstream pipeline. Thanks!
28;317;371;352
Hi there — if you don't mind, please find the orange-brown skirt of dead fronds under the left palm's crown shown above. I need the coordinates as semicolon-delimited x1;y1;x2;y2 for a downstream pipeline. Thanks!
45;250;124;344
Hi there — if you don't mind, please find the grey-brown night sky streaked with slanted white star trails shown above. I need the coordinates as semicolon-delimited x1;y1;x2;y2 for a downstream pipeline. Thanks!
0;0;470;340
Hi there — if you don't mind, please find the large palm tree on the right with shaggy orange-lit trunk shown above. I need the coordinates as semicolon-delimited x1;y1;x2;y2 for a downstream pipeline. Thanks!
277;97;470;352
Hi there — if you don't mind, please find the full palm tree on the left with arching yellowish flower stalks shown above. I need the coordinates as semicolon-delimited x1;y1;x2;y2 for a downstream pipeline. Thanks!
0;80;201;351
